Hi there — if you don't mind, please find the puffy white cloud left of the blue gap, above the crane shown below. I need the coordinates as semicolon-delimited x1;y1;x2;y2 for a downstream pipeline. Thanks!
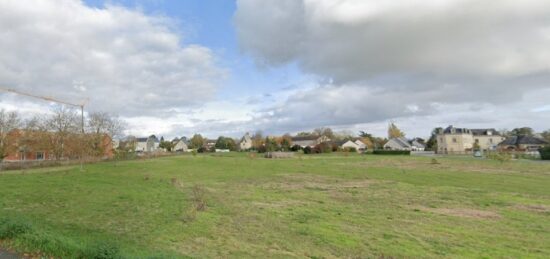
0;0;225;116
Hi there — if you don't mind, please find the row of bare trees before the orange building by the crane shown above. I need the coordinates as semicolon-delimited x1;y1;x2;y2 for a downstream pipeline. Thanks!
0;106;125;162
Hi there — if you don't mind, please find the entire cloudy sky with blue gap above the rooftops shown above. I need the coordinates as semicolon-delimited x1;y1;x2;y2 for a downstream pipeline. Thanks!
0;0;550;140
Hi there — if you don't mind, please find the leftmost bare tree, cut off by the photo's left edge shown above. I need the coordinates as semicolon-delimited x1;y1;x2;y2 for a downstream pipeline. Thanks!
0;109;21;164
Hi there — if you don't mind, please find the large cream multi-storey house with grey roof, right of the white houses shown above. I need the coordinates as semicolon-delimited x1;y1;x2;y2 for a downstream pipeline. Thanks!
436;125;504;154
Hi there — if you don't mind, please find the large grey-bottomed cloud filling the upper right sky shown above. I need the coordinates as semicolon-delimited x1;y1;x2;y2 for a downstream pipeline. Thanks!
235;0;550;102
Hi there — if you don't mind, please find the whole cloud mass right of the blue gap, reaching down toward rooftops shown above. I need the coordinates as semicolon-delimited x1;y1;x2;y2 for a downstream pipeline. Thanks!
234;0;550;136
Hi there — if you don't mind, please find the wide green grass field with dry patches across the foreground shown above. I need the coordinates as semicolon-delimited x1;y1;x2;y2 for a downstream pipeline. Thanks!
0;154;550;258
